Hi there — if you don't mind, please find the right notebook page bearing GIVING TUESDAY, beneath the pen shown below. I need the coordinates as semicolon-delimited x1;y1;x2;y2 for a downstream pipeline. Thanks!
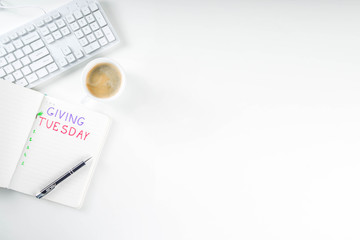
10;97;110;207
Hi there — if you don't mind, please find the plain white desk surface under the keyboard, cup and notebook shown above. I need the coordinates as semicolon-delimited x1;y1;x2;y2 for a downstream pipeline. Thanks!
0;0;360;240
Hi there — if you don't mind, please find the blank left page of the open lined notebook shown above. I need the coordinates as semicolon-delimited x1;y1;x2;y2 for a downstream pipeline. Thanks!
0;79;44;188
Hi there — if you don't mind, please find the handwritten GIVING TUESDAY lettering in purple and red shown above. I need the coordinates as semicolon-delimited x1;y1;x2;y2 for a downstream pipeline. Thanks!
39;107;90;141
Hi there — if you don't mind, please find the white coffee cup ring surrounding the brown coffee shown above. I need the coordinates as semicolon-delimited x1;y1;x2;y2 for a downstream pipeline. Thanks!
82;58;126;101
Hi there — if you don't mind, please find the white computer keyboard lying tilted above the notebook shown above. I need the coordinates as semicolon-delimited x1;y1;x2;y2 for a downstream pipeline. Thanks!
0;0;119;88
